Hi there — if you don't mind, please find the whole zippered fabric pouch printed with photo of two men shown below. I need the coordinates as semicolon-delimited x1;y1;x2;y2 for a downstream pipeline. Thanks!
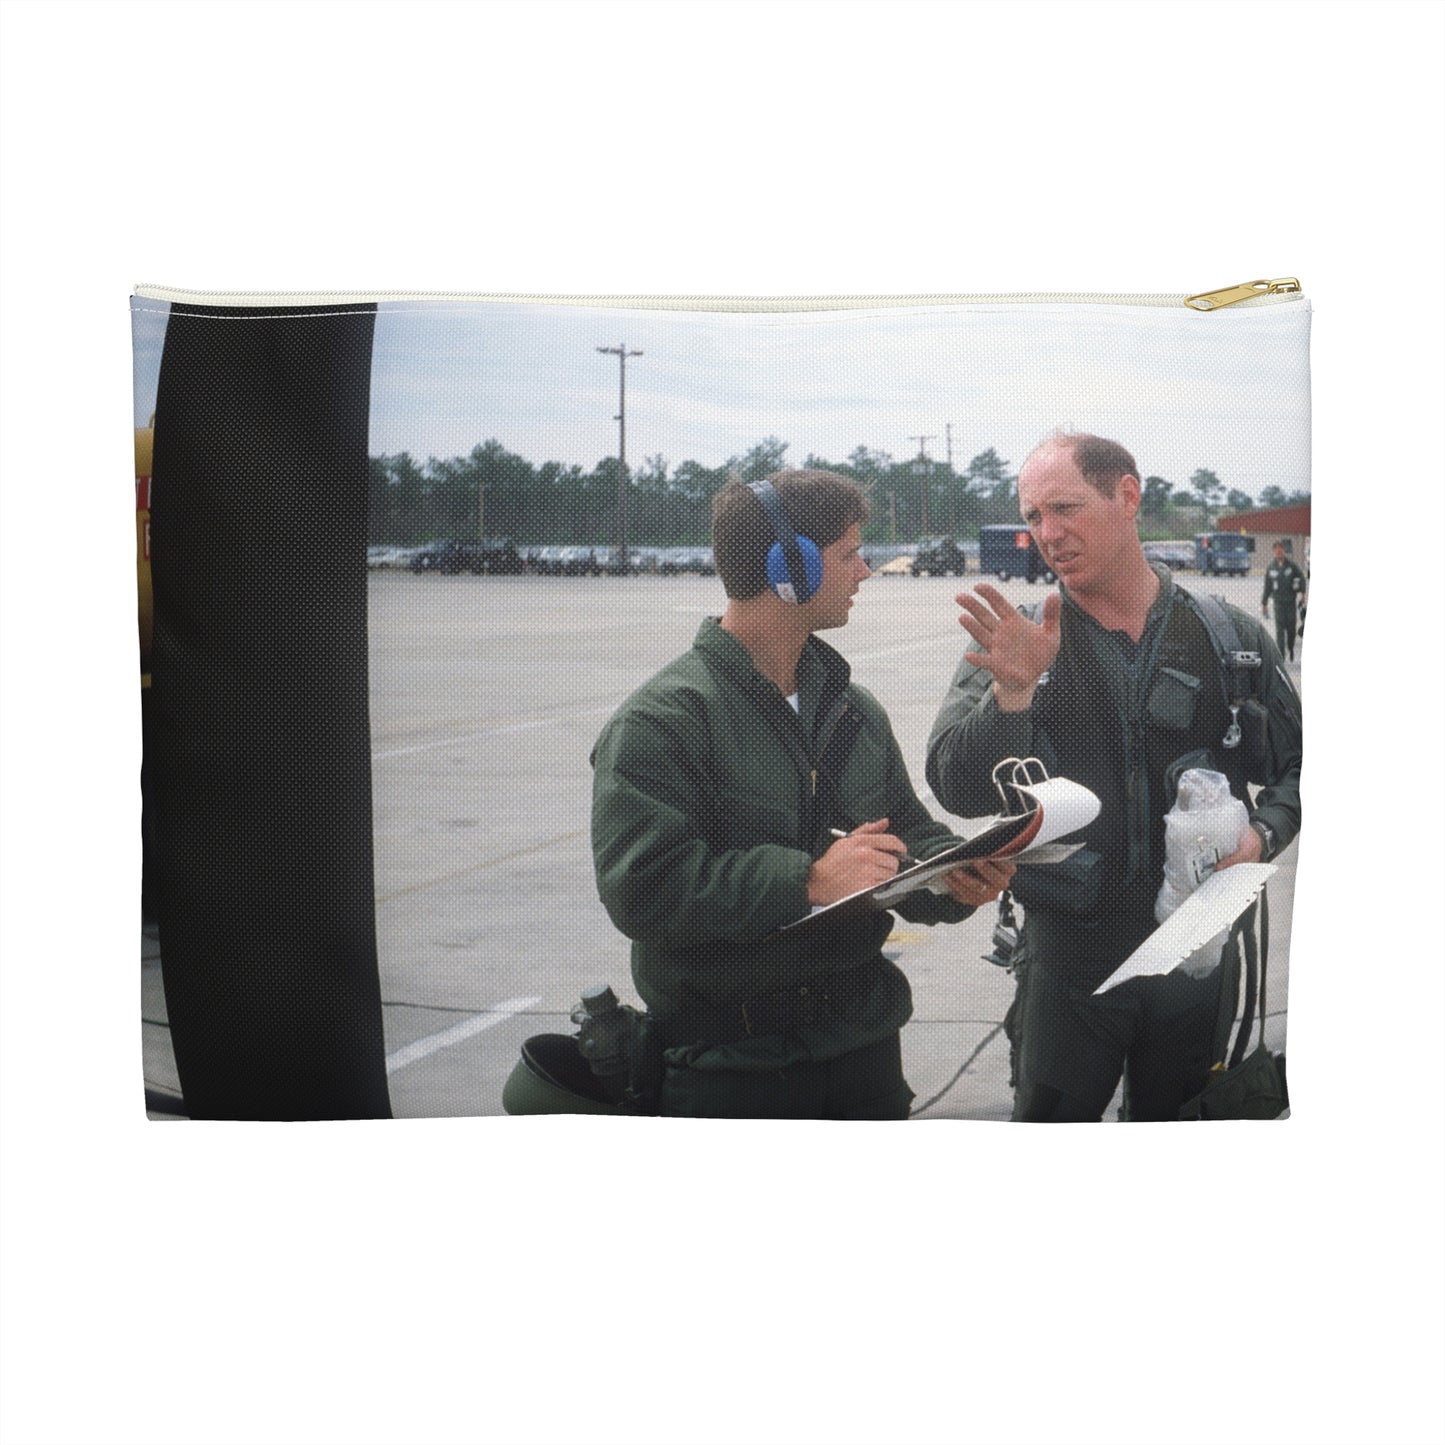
131;280;1311;1127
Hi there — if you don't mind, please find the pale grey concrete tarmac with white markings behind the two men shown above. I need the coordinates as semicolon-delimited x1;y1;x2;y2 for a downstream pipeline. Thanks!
142;571;1299;1120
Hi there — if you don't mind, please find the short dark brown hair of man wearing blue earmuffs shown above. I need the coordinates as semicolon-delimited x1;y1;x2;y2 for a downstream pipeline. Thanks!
712;470;868;601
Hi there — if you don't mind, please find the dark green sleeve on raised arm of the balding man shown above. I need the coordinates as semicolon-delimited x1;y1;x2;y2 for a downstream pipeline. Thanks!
926;660;1035;818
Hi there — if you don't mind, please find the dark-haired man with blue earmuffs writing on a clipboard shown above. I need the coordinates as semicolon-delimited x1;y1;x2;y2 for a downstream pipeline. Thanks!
592;471;1013;1118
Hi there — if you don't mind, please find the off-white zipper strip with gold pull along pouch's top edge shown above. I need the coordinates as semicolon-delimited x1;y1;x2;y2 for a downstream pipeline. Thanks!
136;276;1303;311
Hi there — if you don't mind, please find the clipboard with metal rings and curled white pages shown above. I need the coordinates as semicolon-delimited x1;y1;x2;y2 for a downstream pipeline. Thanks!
775;757;1100;936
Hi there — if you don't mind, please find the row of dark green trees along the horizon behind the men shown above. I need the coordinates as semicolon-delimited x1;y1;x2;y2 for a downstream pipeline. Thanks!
368;436;1308;546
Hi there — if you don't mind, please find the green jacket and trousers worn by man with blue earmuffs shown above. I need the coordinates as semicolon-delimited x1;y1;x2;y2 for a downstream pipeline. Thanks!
592;618;972;1118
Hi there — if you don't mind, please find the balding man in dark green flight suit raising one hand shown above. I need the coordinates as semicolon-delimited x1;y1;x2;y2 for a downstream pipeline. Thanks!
928;434;1301;1123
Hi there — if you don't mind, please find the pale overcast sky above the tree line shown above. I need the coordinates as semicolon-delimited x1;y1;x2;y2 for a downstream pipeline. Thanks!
136;301;1309;497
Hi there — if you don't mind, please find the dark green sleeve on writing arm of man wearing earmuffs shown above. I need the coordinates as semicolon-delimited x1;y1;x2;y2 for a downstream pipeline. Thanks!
592;705;812;945
